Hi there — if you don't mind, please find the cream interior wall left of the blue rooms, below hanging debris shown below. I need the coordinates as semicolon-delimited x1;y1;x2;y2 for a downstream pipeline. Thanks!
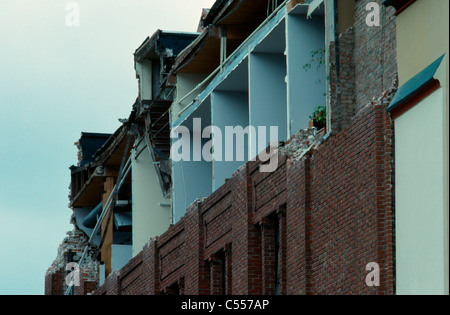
131;141;171;256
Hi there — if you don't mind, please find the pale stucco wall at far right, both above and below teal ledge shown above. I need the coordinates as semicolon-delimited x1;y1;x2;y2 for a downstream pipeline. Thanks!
395;0;449;294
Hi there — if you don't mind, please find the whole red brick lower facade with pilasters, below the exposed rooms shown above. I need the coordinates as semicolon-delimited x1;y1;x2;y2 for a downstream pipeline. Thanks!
87;94;394;295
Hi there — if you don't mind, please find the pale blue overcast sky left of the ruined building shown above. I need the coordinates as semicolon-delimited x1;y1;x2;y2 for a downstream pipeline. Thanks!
0;0;214;295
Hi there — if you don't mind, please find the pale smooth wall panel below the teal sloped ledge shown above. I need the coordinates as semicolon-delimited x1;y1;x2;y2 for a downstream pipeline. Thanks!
395;84;449;295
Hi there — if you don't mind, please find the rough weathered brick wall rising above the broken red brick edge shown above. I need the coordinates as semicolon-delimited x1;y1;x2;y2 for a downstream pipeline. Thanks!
329;0;397;133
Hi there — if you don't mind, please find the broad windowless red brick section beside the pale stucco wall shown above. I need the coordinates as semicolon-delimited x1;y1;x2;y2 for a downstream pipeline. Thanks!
306;102;392;294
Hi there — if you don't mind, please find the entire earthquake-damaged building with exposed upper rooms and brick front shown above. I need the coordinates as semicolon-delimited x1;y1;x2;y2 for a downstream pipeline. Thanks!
45;0;448;295
